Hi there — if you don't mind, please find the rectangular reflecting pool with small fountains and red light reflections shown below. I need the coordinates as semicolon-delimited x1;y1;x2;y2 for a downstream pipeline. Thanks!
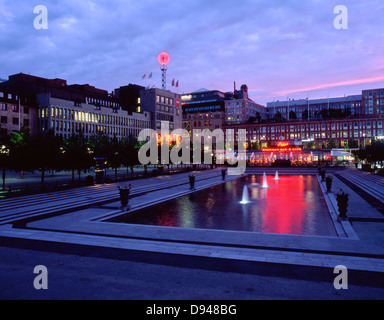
116;175;337;236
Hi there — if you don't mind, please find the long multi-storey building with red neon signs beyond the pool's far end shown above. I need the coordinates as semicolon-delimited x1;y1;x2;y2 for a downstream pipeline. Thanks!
224;89;384;165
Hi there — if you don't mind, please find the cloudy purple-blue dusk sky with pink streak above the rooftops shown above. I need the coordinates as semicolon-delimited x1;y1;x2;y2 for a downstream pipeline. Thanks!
0;0;384;104
